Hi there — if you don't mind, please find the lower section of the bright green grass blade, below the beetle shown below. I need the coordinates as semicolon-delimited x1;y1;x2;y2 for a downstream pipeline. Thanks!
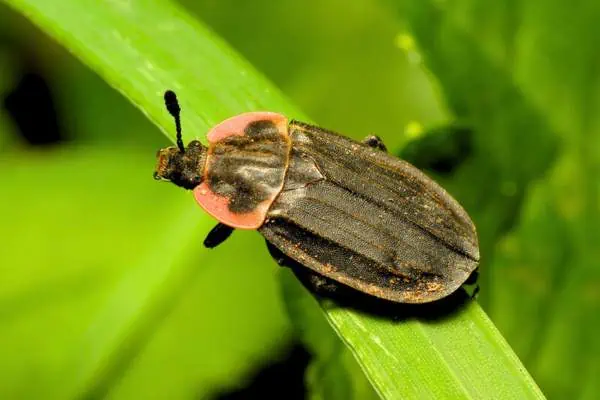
328;303;544;399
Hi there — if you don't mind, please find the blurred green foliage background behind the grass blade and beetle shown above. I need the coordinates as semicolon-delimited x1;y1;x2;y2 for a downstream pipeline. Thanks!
0;0;600;399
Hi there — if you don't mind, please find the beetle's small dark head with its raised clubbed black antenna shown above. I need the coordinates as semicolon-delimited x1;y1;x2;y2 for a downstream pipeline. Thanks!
154;90;206;189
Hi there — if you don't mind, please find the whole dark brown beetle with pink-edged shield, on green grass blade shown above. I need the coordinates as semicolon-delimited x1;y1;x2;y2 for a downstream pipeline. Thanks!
154;91;479;303
